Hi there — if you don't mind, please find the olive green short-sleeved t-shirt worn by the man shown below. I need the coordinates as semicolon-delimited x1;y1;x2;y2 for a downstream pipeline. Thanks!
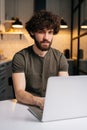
12;46;68;96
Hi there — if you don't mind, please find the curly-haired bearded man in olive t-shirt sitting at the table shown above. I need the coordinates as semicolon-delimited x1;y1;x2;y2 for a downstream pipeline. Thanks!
12;11;68;109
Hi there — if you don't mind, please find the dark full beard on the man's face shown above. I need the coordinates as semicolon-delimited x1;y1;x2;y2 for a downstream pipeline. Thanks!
34;38;52;51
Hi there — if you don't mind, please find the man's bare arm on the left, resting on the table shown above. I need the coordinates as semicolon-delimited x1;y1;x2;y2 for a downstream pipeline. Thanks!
12;73;44;109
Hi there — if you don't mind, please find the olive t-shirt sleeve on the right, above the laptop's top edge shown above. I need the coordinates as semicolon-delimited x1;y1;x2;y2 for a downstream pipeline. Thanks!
60;54;68;71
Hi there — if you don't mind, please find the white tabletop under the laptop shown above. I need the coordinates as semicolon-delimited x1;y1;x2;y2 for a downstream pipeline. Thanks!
0;100;87;130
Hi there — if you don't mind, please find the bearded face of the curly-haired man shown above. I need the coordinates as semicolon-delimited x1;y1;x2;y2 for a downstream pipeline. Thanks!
34;29;53;51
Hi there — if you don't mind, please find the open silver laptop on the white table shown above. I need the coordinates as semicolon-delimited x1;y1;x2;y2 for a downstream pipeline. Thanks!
29;75;87;122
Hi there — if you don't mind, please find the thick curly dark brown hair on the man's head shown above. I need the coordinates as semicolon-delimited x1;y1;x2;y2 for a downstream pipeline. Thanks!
25;10;60;37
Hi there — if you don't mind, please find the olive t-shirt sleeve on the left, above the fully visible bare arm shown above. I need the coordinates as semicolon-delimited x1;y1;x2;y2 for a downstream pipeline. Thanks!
12;53;25;73
